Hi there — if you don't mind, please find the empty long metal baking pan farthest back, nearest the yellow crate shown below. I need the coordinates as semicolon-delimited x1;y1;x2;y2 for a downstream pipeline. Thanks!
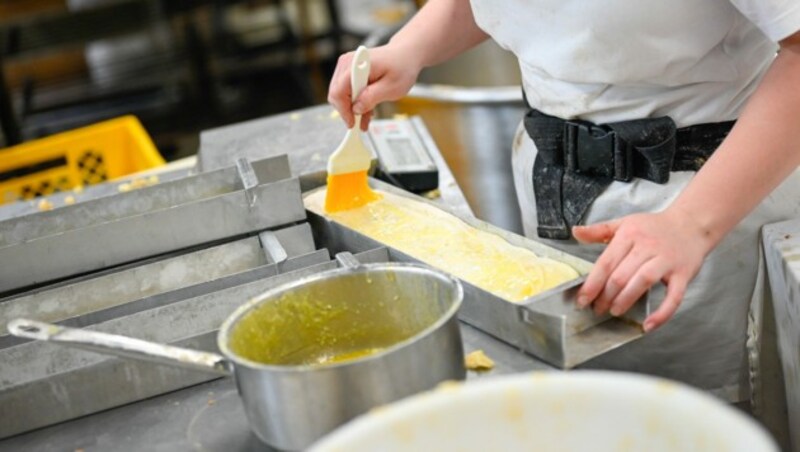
0;155;305;294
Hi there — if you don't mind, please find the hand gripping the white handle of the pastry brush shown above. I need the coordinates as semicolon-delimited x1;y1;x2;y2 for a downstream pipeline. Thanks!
328;43;422;130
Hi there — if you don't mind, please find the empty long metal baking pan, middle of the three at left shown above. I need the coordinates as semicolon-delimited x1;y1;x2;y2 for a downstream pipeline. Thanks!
0;223;330;349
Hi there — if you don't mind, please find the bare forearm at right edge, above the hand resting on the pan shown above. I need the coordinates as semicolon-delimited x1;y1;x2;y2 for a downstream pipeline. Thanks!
669;34;800;251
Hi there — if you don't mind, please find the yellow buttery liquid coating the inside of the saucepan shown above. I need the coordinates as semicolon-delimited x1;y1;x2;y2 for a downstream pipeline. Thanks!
228;272;442;366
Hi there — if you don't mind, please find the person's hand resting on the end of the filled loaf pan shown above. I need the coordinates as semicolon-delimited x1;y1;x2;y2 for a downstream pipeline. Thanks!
572;208;714;332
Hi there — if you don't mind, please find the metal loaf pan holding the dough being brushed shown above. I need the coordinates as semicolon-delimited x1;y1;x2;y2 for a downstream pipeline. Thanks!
308;180;649;369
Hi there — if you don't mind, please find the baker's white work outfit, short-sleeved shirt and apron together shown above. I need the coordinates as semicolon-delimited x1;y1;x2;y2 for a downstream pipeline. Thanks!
471;0;800;401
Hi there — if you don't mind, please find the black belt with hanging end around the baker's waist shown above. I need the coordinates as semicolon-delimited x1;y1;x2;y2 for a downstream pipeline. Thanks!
524;109;734;240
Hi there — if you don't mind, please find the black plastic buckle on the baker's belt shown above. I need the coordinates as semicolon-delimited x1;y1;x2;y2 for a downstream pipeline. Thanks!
564;121;630;180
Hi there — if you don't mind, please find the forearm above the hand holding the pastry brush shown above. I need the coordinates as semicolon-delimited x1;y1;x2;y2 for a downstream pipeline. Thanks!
390;0;488;67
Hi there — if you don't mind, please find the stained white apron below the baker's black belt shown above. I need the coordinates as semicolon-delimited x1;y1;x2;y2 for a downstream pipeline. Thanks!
512;125;800;402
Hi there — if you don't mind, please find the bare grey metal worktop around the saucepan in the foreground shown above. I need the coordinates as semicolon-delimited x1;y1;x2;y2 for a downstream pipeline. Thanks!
0;323;552;452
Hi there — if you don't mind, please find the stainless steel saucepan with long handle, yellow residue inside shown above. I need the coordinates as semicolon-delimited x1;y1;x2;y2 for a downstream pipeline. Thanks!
8;256;465;450
